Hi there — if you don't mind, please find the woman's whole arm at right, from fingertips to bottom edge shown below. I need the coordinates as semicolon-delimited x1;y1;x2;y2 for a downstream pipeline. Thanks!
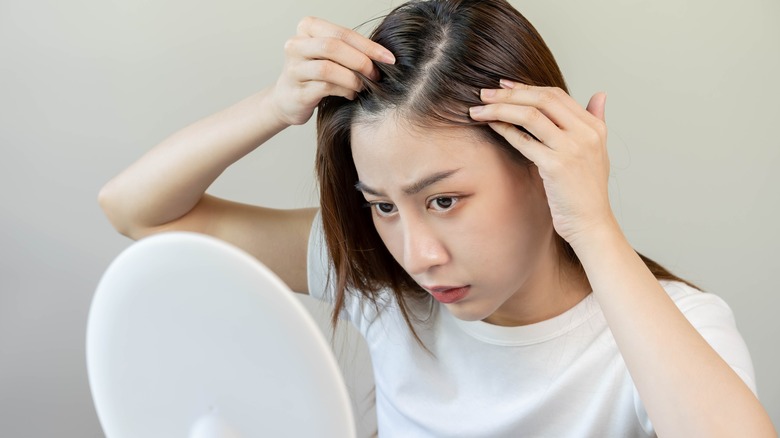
472;81;777;437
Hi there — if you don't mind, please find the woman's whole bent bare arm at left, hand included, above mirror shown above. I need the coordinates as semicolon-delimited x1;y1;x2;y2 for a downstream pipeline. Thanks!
98;18;393;291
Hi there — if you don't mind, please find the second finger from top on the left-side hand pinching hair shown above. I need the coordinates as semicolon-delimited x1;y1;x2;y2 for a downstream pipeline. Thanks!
285;37;379;80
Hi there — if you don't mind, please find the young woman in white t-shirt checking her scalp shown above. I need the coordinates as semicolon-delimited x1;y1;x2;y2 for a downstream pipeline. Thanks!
100;0;776;437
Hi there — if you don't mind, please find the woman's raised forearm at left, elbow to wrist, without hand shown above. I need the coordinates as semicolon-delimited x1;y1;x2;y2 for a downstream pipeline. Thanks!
99;89;287;237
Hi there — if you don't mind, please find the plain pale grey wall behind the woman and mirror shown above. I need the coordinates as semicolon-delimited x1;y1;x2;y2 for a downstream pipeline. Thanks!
0;0;780;437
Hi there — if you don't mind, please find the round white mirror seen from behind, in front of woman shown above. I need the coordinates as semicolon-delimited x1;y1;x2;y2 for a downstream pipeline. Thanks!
87;232;355;438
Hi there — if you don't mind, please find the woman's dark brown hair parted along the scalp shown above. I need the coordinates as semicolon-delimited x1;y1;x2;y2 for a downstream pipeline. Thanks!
317;0;692;341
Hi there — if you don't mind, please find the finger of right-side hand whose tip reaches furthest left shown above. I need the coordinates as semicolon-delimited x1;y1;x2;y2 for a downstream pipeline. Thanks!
470;103;566;149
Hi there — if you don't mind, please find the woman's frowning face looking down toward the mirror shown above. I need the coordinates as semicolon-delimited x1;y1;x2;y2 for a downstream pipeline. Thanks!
352;117;568;325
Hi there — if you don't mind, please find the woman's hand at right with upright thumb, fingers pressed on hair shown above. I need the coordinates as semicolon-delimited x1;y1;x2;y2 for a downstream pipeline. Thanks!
470;80;617;250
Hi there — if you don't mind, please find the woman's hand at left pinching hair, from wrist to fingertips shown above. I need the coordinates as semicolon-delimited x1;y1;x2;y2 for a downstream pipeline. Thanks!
272;17;395;125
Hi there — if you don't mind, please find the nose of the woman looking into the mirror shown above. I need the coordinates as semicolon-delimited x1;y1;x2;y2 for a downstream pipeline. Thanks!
403;218;450;275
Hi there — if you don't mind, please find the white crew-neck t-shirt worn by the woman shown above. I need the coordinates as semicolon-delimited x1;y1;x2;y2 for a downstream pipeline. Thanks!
308;216;755;438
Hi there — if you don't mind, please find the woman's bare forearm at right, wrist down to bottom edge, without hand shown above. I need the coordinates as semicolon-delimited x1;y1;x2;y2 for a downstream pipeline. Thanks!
575;223;776;437
